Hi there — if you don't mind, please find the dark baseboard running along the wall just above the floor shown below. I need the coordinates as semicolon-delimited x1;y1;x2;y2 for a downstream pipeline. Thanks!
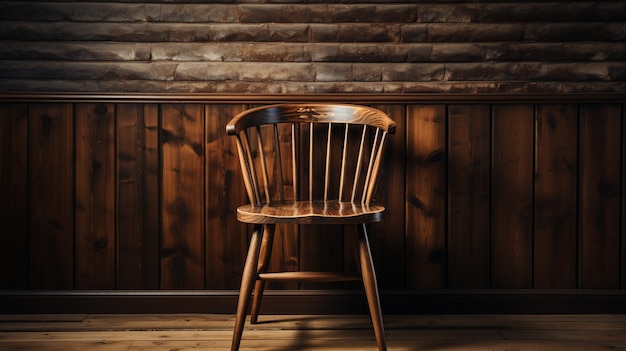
0;290;626;314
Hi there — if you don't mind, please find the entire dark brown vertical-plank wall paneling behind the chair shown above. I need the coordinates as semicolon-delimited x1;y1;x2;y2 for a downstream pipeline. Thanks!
0;95;626;291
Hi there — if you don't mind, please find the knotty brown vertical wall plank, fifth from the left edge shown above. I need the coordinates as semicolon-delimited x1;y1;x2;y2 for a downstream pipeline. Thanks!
161;104;205;289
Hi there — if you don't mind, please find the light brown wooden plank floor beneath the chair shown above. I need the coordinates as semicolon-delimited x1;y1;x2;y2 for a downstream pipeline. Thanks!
0;314;626;351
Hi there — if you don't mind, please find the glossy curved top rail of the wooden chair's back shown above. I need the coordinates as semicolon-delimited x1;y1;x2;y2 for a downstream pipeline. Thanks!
226;103;396;135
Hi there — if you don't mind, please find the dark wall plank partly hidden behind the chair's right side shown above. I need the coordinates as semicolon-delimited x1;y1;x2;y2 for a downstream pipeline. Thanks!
370;105;407;289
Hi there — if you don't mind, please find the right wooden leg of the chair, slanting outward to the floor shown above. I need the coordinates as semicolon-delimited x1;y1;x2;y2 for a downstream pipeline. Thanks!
359;224;387;351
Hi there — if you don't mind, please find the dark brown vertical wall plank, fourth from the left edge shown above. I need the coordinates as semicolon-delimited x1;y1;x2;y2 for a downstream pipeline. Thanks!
116;104;159;289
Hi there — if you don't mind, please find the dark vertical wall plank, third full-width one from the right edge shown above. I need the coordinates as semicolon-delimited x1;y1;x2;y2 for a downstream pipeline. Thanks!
491;105;534;289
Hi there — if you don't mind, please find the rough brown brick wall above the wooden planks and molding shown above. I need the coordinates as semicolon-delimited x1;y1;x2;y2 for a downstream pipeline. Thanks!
0;0;626;94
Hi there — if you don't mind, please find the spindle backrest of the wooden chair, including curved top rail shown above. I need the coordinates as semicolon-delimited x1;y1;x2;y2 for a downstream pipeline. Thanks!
226;104;395;206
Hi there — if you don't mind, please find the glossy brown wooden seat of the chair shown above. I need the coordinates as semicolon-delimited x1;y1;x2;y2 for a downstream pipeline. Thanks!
237;200;385;224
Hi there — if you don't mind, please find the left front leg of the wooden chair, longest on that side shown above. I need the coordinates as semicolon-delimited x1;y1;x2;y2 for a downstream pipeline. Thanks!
230;226;263;351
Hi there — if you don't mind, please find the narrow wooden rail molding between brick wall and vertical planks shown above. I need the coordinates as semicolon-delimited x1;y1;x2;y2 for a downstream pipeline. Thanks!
0;92;626;104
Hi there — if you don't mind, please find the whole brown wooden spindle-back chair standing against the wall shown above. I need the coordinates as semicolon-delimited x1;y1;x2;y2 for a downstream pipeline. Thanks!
226;104;395;351
